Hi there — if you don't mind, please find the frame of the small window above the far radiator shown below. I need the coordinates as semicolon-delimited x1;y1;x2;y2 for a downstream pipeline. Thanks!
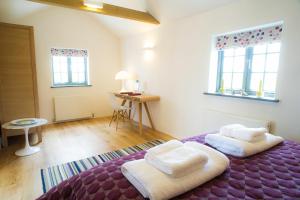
51;55;89;87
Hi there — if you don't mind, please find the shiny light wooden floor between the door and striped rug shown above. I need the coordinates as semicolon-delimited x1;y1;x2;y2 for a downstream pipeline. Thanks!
0;118;171;200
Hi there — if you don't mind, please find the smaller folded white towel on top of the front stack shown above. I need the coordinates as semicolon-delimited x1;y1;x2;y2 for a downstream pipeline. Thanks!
145;142;208;178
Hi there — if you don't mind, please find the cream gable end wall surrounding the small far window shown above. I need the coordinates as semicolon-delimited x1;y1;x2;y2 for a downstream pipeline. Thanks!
1;7;121;121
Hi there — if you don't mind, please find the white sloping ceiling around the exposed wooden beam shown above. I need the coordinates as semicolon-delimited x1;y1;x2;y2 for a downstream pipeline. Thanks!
0;0;238;37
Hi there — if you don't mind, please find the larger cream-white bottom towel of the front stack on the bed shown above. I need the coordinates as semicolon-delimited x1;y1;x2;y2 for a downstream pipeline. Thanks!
121;143;229;200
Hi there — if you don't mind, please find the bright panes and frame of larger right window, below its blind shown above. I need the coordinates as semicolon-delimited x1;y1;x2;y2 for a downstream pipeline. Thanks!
217;42;280;97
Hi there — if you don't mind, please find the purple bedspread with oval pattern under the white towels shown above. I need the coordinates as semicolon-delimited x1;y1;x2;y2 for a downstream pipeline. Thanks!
39;135;300;200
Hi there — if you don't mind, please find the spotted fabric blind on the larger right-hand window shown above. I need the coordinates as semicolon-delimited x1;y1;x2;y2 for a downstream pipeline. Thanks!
216;24;282;50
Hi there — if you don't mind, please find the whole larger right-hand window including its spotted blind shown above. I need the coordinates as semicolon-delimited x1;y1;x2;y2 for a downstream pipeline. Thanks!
215;22;282;98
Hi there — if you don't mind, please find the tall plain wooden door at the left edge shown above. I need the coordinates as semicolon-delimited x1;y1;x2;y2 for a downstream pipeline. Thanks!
0;23;39;123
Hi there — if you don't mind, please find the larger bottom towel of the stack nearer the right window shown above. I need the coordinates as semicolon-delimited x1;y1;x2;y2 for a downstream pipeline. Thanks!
205;133;283;157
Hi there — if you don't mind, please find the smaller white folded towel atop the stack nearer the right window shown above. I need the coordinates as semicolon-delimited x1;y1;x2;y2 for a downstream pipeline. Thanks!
220;124;267;142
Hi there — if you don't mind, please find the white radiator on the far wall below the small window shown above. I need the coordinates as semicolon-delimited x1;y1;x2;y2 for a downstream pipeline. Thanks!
54;96;93;122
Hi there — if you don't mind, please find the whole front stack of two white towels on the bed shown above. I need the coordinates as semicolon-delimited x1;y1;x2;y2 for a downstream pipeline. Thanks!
121;140;229;200
